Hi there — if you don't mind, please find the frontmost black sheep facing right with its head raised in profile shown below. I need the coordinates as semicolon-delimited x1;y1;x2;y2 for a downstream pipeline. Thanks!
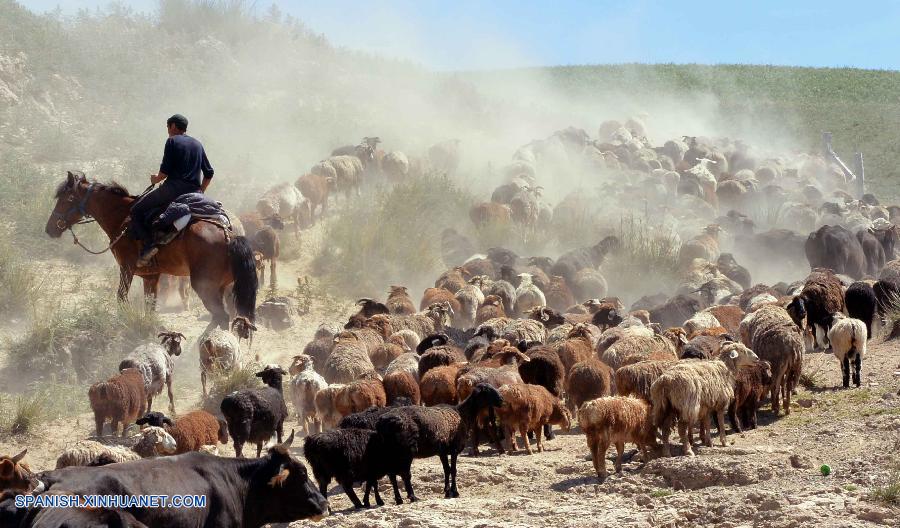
375;383;503;504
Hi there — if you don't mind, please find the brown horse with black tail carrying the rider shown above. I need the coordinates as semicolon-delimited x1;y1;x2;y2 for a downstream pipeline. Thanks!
46;172;258;330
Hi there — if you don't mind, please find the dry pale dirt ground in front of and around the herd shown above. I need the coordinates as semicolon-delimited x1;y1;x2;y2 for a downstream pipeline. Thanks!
0;231;900;528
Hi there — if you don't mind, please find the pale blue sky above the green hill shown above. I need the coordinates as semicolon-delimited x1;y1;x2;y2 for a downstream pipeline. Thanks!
20;0;900;70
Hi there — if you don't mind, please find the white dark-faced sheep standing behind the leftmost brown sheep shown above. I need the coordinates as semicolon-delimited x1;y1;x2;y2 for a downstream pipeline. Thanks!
119;332;184;413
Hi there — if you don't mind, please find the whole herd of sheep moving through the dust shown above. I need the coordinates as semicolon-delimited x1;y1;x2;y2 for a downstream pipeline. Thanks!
5;119;900;507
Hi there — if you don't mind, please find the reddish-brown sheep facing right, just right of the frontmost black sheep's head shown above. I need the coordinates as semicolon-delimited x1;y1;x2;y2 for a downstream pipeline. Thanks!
497;383;572;455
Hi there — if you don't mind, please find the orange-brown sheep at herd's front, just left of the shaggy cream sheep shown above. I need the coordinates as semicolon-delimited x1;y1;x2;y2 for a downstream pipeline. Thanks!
578;396;656;482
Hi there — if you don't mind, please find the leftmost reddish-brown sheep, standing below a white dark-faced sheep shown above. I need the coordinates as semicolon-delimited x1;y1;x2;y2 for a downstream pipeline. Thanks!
88;368;147;437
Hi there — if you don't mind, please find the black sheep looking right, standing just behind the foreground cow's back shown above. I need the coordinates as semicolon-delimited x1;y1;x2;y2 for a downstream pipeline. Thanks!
220;366;288;458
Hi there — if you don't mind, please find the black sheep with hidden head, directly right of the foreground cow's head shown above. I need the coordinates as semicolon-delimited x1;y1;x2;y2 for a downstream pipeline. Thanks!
303;429;388;510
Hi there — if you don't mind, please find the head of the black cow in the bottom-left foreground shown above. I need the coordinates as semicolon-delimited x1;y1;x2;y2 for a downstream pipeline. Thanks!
244;431;328;526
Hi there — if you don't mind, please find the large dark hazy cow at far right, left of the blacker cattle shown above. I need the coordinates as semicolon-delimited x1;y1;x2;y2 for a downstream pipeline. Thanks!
804;225;866;279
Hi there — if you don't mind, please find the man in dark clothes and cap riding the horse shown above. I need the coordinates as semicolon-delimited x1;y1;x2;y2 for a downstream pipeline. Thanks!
131;114;214;267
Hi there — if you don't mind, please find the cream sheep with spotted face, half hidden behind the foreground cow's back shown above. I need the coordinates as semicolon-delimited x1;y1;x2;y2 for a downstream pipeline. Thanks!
56;427;178;469
